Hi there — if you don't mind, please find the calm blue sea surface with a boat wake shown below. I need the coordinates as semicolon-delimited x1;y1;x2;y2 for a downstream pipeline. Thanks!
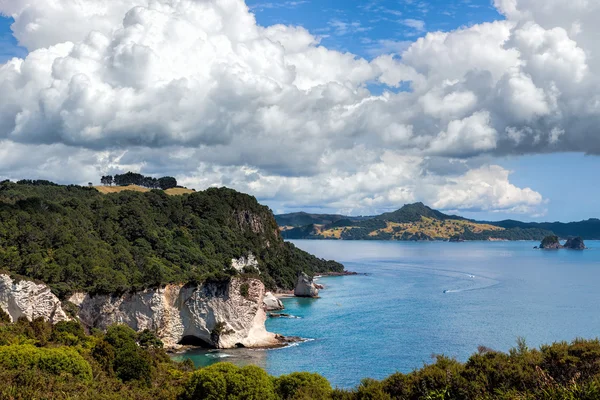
173;240;600;388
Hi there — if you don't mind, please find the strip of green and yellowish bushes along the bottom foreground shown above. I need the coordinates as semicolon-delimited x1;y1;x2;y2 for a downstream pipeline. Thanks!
0;311;600;400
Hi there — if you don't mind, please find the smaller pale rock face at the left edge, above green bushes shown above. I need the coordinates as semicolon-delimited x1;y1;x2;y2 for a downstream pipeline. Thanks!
0;275;69;324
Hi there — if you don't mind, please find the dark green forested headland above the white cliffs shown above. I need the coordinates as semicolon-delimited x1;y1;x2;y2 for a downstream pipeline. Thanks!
0;181;343;297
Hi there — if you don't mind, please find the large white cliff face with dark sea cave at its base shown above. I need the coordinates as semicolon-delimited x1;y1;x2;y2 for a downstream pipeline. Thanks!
69;279;280;349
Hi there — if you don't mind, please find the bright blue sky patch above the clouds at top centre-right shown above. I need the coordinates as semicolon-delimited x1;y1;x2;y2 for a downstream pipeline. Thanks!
247;0;502;59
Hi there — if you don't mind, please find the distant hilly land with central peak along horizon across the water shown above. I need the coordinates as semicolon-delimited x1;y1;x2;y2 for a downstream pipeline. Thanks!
275;203;600;242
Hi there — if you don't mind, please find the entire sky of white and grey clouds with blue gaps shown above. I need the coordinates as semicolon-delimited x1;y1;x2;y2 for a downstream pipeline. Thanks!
0;0;600;221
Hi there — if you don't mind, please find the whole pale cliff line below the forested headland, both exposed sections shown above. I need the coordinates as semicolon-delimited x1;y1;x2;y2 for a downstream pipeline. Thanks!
0;275;281;349
